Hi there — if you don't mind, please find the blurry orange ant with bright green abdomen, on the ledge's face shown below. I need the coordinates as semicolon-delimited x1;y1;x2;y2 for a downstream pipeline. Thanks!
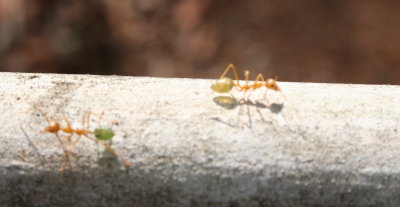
30;108;131;172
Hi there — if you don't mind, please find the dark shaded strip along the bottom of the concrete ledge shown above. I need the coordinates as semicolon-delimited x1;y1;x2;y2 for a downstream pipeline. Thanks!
0;163;400;207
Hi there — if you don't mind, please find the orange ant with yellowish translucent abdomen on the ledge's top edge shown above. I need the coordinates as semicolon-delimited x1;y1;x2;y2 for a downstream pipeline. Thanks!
211;64;281;100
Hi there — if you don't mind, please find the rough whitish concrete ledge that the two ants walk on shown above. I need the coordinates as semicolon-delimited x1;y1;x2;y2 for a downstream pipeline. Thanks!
0;73;400;207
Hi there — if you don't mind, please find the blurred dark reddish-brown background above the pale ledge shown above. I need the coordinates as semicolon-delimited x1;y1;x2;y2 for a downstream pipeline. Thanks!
0;0;400;84
